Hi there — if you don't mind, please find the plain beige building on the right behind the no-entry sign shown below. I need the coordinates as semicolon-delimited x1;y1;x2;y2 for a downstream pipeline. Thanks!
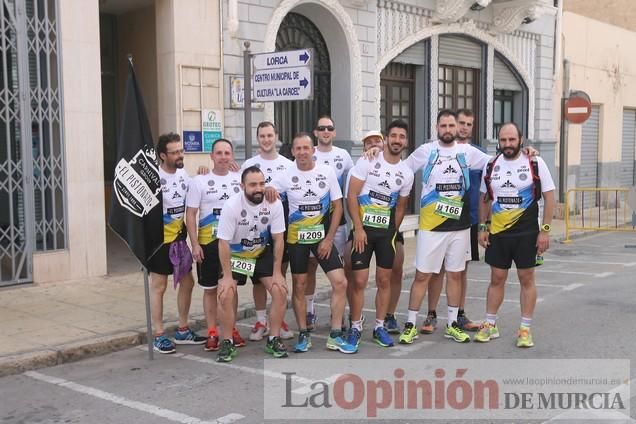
554;0;636;206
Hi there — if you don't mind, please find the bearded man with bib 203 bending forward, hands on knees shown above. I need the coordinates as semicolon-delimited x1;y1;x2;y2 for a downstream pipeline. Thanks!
217;166;287;362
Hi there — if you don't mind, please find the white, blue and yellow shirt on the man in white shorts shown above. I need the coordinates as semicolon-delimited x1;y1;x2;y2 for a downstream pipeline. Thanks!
404;140;490;231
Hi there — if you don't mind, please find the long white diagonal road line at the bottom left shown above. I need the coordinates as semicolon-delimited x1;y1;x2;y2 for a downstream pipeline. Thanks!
24;371;245;424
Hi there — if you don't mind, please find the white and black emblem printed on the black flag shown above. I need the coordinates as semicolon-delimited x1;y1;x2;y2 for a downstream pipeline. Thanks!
113;148;161;218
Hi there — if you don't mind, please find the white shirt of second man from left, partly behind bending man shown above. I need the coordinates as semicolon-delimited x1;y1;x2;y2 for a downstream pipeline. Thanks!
186;172;241;245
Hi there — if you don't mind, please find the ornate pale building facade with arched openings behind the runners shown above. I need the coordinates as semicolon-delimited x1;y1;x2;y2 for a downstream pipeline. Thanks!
0;0;558;285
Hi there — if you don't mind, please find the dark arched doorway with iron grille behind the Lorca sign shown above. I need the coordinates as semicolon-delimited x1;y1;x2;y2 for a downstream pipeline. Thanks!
274;13;331;156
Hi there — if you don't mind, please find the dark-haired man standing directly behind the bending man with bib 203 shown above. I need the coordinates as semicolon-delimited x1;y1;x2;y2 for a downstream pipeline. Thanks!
241;121;294;341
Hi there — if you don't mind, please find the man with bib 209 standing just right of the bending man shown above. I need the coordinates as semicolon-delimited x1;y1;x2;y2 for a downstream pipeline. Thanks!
266;133;356;353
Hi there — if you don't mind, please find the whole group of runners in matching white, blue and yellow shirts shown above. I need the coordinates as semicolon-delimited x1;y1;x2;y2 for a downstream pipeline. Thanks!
148;110;554;362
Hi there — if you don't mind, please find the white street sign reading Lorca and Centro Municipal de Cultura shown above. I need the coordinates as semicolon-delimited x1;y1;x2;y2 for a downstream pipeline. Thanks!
253;49;314;102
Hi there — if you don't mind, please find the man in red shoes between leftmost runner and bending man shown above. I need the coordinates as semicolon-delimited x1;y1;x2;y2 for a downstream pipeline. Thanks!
186;138;245;351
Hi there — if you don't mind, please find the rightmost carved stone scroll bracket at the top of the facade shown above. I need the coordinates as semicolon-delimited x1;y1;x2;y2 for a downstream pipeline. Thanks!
492;0;557;33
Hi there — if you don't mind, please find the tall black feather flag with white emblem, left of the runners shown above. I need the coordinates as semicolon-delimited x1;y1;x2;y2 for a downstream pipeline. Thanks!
108;60;163;267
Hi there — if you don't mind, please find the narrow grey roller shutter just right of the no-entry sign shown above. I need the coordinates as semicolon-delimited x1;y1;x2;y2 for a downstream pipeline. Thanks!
577;106;600;208
